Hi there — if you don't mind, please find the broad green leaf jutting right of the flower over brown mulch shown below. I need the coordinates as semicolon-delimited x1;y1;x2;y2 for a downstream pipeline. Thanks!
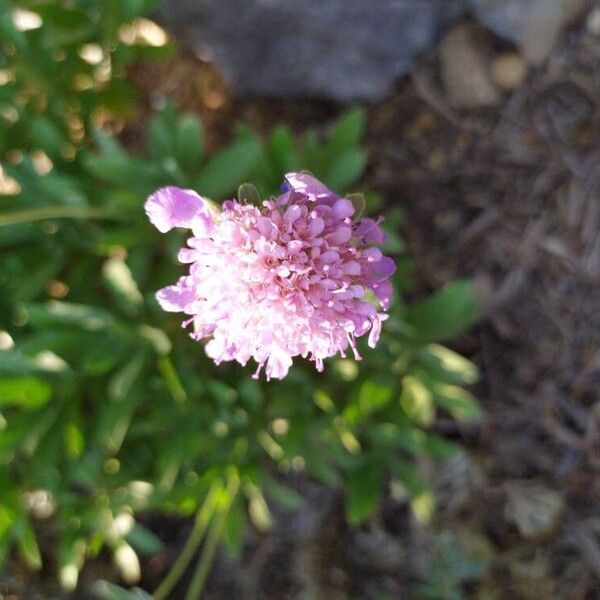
405;281;479;342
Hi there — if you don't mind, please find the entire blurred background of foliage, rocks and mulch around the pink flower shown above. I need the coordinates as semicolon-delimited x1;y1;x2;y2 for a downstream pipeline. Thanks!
0;0;600;600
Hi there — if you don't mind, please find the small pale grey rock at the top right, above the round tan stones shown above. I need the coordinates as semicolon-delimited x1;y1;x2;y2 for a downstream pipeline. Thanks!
468;0;584;66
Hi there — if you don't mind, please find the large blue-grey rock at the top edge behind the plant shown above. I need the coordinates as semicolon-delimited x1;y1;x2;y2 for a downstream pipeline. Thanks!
158;0;464;102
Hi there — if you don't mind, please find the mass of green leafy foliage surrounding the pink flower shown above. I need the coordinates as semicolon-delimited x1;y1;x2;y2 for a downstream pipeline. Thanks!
0;0;481;598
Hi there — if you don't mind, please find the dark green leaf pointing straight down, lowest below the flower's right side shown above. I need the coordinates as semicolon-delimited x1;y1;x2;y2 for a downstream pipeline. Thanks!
346;462;382;525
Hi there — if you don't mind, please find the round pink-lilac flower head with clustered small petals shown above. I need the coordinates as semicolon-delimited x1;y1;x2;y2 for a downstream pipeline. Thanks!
145;173;395;379
